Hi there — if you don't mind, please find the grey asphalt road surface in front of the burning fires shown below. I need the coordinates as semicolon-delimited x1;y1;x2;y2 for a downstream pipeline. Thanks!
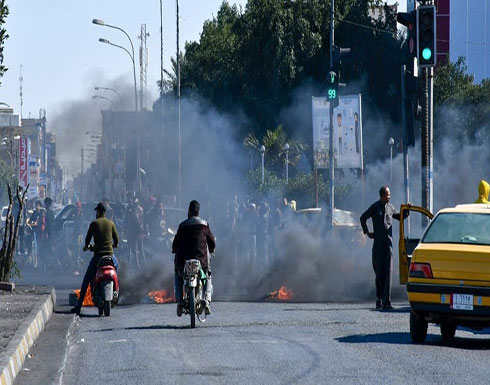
12;293;490;385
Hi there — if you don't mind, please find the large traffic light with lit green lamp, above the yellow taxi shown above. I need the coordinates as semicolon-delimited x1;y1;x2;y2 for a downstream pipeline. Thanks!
417;5;437;68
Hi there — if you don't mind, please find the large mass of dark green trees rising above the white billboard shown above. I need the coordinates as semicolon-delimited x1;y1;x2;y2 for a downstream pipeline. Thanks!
161;0;402;142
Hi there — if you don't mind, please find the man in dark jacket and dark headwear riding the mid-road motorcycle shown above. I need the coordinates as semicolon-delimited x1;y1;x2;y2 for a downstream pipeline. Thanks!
172;200;216;317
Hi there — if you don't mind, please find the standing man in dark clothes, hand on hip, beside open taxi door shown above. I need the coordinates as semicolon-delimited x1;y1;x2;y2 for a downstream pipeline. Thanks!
361;186;408;310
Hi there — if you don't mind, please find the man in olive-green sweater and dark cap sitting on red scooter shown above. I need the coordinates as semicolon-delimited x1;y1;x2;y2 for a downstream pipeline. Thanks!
71;202;119;315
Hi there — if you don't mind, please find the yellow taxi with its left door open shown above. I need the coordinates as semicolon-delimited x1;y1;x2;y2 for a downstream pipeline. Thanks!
399;204;490;343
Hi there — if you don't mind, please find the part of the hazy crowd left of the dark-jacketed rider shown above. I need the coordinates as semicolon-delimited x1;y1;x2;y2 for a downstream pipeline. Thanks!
13;197;171;271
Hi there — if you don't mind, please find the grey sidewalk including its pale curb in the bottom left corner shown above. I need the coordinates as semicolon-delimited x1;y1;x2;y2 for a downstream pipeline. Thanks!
0;286;56;385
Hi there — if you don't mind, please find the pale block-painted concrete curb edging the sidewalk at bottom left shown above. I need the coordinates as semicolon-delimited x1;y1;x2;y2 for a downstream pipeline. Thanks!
0;288;56;385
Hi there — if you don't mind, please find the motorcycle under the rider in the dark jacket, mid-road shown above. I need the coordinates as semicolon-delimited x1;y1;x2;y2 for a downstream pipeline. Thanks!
183;259;207;328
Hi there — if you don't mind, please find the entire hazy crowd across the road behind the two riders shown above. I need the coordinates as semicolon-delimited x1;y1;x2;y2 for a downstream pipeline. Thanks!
14;188;310;271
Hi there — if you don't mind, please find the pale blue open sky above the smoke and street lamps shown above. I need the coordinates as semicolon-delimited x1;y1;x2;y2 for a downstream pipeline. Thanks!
0;0;400;119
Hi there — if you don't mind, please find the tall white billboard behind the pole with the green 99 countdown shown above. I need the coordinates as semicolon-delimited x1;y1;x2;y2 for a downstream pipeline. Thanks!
311;94;363;169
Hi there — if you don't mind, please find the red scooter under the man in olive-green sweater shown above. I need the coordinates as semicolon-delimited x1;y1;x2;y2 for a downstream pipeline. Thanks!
88;245;119;317
